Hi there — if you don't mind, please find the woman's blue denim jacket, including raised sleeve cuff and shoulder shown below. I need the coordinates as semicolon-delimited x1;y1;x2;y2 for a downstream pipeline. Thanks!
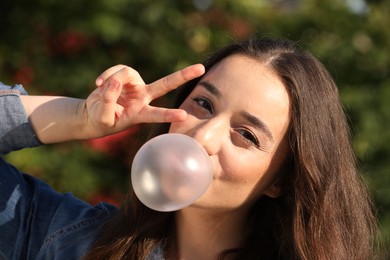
0;83;117;260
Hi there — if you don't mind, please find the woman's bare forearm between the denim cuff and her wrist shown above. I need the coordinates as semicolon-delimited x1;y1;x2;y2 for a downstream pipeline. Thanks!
20;96;88;144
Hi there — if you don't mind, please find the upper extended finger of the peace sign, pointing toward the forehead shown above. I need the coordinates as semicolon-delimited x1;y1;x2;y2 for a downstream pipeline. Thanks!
146;64;205;99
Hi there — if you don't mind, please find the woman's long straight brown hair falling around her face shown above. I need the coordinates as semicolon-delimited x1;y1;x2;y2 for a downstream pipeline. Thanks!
87;37;377;260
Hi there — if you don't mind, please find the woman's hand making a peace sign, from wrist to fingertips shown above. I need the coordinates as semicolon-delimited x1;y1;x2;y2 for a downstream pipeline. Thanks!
82;64;204;136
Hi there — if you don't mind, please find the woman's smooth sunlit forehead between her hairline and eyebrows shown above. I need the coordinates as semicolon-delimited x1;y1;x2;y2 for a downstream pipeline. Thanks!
201;55;290;139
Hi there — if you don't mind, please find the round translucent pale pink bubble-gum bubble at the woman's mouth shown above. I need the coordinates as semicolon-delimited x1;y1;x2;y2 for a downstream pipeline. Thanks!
131;134;213;212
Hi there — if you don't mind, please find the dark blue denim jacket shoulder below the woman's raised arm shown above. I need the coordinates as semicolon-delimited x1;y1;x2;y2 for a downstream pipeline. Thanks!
0;158;117;259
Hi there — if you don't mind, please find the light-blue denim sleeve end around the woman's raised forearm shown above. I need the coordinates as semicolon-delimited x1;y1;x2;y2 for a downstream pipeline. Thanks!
0;82;41;155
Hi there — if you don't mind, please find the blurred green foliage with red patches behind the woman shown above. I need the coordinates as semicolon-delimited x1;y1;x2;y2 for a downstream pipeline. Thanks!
0;0;390;256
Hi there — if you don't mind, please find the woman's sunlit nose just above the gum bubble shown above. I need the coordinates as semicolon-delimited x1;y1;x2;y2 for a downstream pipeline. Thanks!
190;120;225;155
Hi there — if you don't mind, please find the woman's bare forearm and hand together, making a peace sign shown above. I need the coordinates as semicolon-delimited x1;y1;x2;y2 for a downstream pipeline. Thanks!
20;64;204;143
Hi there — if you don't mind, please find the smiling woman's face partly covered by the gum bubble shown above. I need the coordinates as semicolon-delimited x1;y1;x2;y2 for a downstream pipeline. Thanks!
169;55;290;210
